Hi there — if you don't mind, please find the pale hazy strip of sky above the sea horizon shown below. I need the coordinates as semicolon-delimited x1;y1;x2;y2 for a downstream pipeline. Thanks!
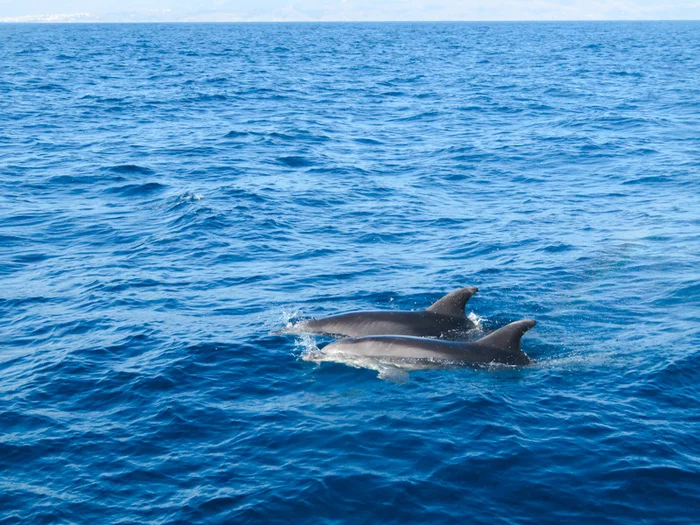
0;0;700;22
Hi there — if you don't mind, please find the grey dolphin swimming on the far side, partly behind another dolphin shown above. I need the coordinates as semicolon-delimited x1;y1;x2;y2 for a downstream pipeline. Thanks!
293;287;478;339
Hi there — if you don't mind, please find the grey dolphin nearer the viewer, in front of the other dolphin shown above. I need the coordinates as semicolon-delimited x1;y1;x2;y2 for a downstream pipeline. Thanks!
312;319;537;368
